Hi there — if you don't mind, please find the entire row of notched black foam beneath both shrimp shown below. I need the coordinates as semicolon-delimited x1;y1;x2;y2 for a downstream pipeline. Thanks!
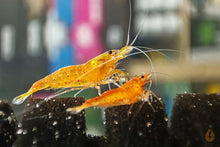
0;94;220;147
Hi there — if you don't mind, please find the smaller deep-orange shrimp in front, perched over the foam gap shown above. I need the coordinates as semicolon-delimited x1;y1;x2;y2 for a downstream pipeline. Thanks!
67;73;151;113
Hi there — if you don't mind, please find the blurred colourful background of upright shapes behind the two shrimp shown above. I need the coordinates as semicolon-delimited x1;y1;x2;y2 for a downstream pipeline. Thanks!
0;0;220;134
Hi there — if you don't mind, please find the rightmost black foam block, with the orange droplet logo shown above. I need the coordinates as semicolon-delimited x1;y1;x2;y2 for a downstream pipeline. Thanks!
168;94;220;147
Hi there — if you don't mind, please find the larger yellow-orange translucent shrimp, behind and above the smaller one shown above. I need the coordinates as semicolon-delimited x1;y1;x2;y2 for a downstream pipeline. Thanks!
12;50;128;104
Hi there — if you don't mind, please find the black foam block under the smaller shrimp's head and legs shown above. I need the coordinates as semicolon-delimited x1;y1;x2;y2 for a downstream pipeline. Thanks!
105;97;168;147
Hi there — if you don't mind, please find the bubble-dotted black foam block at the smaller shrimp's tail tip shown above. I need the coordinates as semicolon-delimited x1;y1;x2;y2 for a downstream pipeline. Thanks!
14;98;85;147
